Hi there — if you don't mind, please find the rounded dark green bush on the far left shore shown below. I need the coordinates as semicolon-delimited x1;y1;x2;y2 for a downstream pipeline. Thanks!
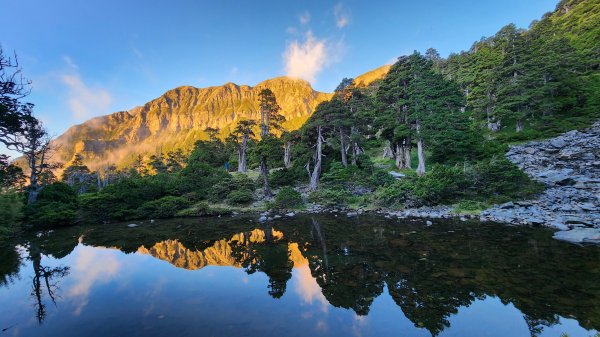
24;182;77;227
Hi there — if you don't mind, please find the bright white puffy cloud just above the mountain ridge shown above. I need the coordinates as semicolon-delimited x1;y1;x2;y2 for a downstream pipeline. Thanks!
283;31;344;83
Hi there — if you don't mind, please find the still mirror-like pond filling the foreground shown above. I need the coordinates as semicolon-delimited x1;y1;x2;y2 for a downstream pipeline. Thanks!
0;217;600;337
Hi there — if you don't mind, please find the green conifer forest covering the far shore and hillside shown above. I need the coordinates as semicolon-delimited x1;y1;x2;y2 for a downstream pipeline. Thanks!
0;0;600;236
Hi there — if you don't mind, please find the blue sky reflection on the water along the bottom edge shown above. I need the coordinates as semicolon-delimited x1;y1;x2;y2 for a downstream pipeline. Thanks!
0;245;591;337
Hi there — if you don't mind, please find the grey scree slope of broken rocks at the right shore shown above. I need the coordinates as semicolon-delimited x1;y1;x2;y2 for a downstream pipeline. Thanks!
481;122;600;243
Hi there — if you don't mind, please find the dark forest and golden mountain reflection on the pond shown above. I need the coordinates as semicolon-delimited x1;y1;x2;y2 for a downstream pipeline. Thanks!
41;216;600;335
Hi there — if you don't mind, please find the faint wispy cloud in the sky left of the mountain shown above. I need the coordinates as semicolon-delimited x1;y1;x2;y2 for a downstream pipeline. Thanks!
60;56;112;121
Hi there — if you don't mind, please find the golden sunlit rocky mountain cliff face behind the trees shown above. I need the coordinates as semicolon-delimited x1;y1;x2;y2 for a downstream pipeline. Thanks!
56;77;332;169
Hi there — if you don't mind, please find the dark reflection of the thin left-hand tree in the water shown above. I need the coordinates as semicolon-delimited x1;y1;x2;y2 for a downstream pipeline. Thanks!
29;246;69;324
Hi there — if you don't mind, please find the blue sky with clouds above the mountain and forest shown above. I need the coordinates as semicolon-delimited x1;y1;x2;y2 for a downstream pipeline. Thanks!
0;0;557;143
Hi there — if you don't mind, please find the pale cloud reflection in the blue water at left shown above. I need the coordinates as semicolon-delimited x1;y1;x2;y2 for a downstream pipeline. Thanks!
68;246;121;315
